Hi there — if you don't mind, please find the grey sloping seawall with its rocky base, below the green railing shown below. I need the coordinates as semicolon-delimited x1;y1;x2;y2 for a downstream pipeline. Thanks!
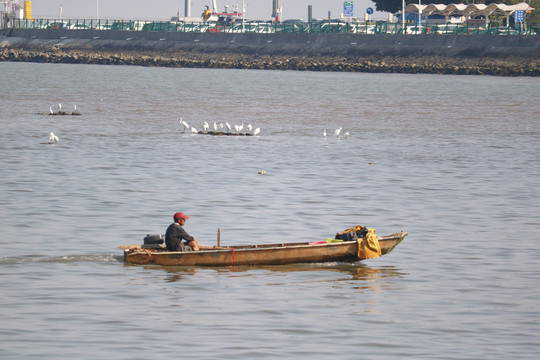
0;29;540;76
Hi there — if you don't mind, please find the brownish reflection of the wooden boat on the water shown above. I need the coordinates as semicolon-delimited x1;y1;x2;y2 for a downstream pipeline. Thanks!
133;262;408;290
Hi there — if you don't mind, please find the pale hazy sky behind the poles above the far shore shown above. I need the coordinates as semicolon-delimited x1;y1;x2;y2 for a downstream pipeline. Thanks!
27;0;387;20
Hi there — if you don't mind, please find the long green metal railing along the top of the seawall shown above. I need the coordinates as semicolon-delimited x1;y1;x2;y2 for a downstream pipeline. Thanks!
9;19;540;35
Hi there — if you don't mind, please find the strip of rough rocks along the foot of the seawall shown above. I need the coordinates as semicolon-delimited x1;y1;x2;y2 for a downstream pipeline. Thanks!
0;45;540;77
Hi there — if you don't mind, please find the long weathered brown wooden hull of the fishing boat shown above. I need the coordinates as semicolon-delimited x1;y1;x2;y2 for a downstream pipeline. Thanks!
120;232;408;266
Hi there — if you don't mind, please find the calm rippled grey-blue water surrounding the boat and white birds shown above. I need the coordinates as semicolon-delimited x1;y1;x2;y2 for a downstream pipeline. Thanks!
0;63;540;359
